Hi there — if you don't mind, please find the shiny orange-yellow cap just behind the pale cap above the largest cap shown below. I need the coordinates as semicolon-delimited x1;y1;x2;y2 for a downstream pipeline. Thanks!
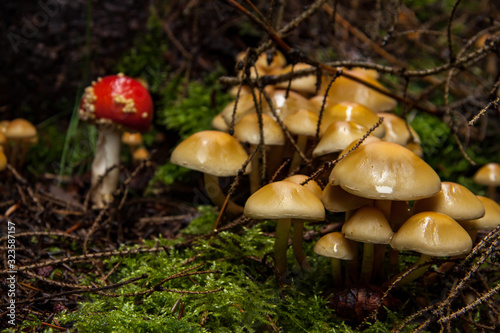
321;102;385;138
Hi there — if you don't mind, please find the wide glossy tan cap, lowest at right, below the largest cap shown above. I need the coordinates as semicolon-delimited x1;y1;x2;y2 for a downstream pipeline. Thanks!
391;212;472;257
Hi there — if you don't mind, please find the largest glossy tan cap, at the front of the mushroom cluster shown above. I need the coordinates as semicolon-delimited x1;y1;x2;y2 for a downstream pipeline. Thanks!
330;141;441;201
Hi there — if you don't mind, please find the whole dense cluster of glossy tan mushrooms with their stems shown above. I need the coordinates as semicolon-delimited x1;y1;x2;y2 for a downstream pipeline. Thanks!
171;52;500;285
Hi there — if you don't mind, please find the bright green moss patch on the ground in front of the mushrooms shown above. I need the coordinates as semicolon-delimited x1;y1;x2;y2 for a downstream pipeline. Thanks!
58;214;418;332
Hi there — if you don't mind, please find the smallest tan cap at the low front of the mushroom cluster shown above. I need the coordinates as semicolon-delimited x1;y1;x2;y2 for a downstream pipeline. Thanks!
313;232;358;260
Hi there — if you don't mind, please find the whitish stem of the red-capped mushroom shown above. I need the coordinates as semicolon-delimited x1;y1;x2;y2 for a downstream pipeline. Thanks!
91;126;121;208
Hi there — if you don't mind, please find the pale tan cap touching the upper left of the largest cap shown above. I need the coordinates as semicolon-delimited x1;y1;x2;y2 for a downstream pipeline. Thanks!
313;121;368;157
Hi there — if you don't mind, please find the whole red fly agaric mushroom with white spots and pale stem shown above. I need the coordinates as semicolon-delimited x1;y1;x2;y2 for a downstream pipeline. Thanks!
79;73;153;208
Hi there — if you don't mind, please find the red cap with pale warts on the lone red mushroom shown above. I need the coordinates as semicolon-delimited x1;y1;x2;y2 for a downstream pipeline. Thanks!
80;73;153;132
